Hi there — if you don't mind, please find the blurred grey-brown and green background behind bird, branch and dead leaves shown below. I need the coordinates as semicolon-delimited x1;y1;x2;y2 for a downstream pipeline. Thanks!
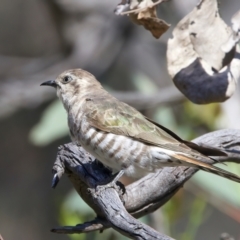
0;0;240;240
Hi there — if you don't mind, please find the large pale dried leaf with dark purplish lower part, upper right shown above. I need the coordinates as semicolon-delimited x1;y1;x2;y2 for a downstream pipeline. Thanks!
167;0;240;104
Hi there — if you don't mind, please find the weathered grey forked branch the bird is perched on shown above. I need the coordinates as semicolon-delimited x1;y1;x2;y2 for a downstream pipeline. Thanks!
52;129;240;239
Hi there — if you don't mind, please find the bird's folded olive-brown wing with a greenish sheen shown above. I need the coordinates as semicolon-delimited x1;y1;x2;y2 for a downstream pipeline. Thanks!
84;97;196;152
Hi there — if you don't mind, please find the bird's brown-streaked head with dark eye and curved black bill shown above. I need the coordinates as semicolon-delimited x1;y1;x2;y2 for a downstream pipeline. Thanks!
41;69;102;109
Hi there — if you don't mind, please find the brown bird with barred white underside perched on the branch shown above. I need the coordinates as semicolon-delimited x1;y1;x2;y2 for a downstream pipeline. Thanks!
41;68;240;182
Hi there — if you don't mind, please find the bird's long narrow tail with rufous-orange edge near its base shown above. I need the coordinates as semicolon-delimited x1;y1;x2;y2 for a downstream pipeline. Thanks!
174;154;240;183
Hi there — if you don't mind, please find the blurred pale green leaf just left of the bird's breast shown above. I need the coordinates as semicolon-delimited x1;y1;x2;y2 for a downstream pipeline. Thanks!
29;100;68;146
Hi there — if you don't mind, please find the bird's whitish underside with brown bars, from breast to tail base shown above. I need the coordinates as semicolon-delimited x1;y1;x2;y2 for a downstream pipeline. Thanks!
67;117;182;178
